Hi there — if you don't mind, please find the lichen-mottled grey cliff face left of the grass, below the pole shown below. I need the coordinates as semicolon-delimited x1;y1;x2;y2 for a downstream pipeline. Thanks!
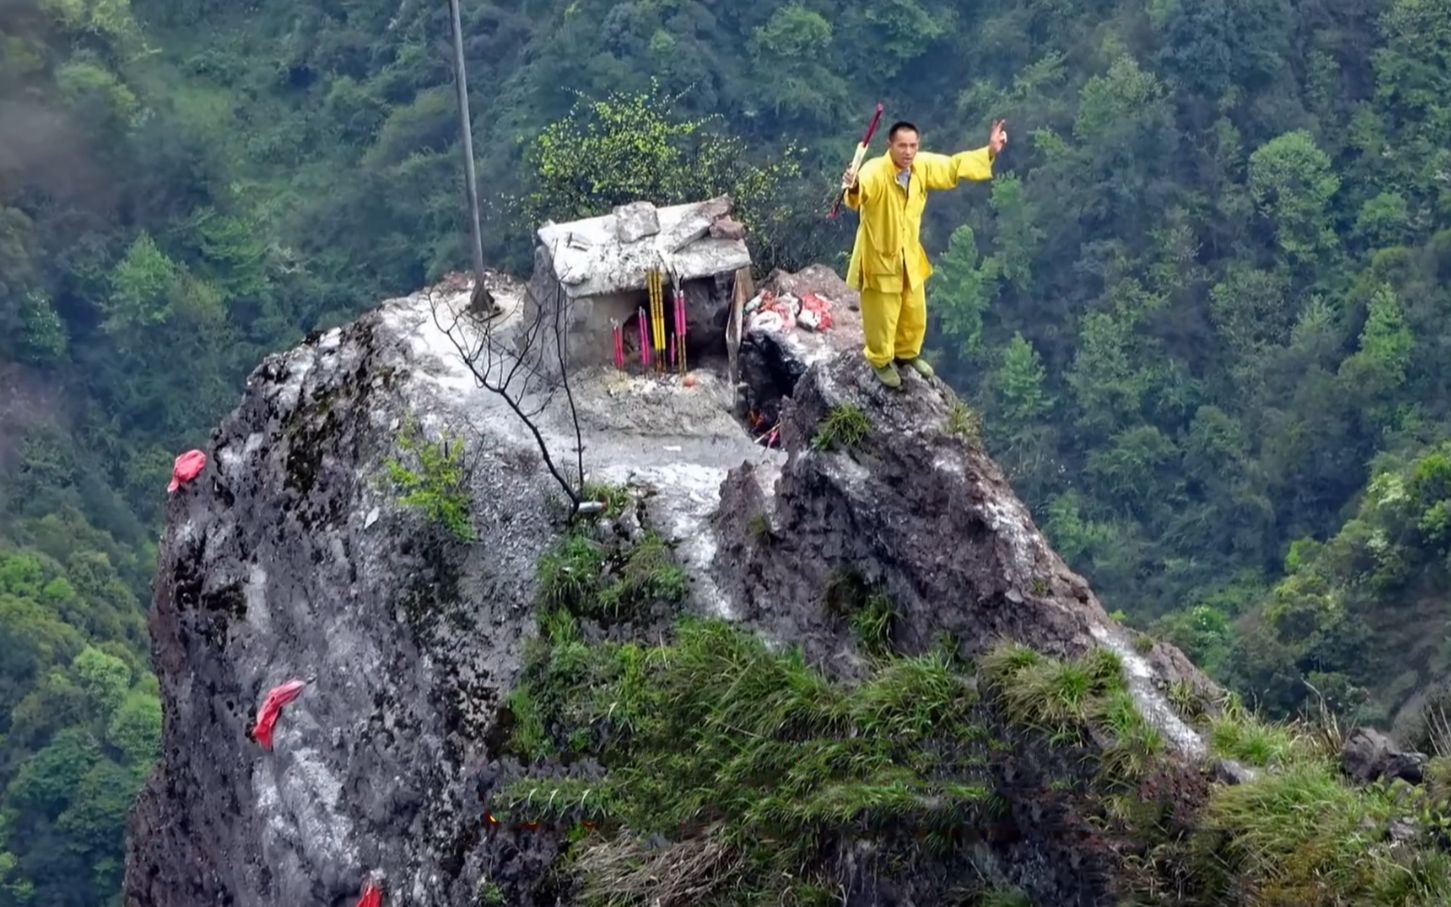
126;293;554;907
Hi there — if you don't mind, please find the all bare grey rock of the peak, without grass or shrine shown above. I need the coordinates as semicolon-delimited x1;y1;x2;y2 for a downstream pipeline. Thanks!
126;268;1216;907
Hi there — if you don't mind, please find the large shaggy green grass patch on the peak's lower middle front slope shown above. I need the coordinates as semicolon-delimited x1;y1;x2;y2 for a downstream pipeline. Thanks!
499;618;990;904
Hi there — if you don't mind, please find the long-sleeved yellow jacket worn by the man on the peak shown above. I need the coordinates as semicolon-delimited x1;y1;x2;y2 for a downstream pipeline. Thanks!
846;147;992;293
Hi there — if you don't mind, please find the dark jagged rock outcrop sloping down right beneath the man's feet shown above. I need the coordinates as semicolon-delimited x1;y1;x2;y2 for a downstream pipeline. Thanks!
717;353;1212;691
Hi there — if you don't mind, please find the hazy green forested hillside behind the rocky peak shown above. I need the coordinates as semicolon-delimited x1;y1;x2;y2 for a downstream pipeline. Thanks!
0;0;1451;907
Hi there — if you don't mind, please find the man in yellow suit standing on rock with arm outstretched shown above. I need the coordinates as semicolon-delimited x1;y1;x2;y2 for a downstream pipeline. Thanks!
842;119;1007;387
